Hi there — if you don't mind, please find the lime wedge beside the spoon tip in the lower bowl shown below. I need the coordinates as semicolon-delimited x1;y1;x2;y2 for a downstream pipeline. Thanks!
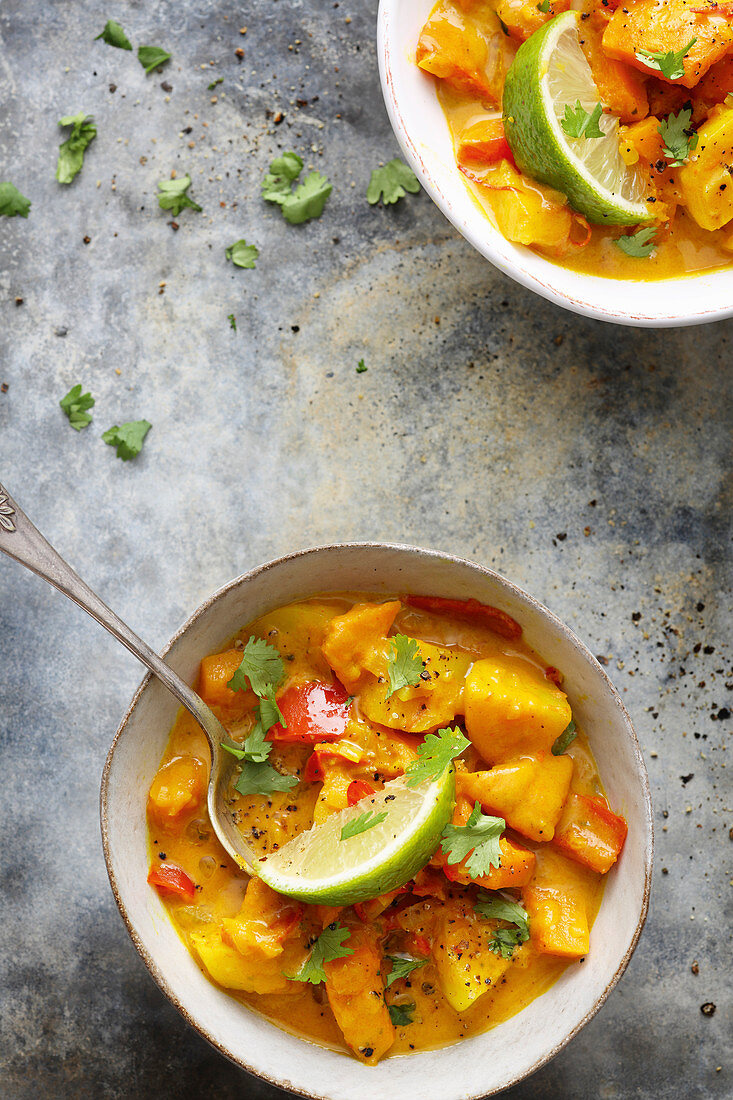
255;765;456;905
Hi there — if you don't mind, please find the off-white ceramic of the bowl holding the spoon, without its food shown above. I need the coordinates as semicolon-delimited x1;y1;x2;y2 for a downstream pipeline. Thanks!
101;543;653;1100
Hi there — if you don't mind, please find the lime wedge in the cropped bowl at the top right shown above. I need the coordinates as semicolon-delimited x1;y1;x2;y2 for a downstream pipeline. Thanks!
503;11;653;226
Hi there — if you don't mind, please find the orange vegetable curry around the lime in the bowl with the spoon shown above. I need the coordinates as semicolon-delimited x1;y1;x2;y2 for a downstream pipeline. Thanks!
147;594;626;1065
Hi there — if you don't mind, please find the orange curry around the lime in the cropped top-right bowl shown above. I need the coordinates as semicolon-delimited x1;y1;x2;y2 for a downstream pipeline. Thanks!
416;0;733;279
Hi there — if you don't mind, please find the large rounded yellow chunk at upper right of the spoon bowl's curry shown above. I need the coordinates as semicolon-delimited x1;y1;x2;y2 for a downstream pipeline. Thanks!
463;657;572;765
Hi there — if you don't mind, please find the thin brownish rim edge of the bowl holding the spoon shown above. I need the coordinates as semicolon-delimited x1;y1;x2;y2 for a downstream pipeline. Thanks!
99;541;654;1100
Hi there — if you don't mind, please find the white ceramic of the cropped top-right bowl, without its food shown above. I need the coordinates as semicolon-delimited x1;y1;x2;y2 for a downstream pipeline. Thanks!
378;0;733;327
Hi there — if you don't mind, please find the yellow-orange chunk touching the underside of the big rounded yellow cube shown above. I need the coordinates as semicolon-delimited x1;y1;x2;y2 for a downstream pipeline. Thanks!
457;752;572;840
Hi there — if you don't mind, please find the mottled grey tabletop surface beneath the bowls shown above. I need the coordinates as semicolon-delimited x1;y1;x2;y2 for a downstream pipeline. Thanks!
0;0;733;1100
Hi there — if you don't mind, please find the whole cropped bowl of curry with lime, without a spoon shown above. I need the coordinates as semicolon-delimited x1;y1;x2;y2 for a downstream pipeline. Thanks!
378;0;733;327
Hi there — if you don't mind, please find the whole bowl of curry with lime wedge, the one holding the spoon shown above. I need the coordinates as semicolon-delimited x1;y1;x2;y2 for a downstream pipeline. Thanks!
101;543;653;1100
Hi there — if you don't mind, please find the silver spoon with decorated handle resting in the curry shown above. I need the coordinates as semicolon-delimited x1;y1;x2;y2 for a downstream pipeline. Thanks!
0;485;253;872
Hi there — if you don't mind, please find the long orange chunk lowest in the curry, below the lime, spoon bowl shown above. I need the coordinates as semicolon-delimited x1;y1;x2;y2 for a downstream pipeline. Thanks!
324;925;394;1066
